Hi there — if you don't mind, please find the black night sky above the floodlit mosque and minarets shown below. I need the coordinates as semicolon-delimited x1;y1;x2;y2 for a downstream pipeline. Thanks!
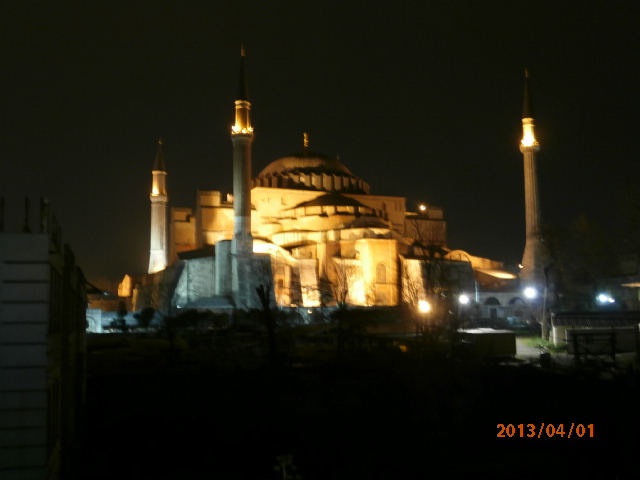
0;0;640;280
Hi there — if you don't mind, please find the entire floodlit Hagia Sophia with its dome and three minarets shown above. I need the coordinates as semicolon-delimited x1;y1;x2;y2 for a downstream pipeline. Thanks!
119;55;539;313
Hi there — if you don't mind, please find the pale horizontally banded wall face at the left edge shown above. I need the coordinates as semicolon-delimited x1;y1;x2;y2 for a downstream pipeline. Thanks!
0;234;50;479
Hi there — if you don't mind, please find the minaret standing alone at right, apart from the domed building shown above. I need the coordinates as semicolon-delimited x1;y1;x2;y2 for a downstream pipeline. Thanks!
520;69;544;292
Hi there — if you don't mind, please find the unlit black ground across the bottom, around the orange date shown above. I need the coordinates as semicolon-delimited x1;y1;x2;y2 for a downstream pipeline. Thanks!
79;346;640;480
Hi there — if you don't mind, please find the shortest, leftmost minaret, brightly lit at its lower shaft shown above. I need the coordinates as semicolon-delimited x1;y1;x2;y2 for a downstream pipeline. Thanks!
149;140;168;273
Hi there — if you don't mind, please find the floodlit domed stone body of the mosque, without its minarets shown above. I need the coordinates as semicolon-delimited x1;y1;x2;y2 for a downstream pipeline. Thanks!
148;135;452;307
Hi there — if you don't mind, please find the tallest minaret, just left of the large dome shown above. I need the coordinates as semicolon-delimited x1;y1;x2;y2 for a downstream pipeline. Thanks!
231;48;253;255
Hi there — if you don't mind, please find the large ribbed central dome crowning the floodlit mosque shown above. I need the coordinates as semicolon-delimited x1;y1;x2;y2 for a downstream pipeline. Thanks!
254;149;370;194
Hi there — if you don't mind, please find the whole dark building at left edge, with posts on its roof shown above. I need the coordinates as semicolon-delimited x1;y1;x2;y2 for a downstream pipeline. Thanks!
0;201;87;480
